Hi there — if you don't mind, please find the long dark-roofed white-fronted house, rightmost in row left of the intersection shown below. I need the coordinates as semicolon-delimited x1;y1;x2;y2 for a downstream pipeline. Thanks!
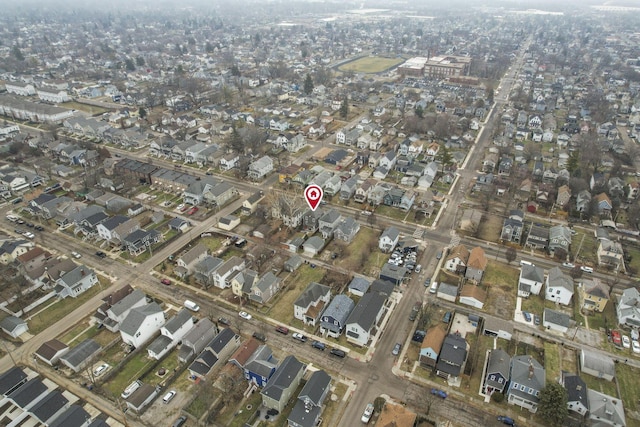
345;293;386;347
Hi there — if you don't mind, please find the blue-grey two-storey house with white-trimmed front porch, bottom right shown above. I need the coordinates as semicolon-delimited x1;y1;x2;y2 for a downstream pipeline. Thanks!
507;356;545;414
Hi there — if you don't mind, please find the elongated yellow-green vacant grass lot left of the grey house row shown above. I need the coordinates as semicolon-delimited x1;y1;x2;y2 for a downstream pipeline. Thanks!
268;264;326;324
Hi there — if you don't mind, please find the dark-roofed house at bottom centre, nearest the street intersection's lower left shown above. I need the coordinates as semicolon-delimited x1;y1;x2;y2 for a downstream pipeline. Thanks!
287;370;331;427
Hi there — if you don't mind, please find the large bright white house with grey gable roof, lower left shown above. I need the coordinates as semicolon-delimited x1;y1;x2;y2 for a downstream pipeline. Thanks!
120;302;164;348
